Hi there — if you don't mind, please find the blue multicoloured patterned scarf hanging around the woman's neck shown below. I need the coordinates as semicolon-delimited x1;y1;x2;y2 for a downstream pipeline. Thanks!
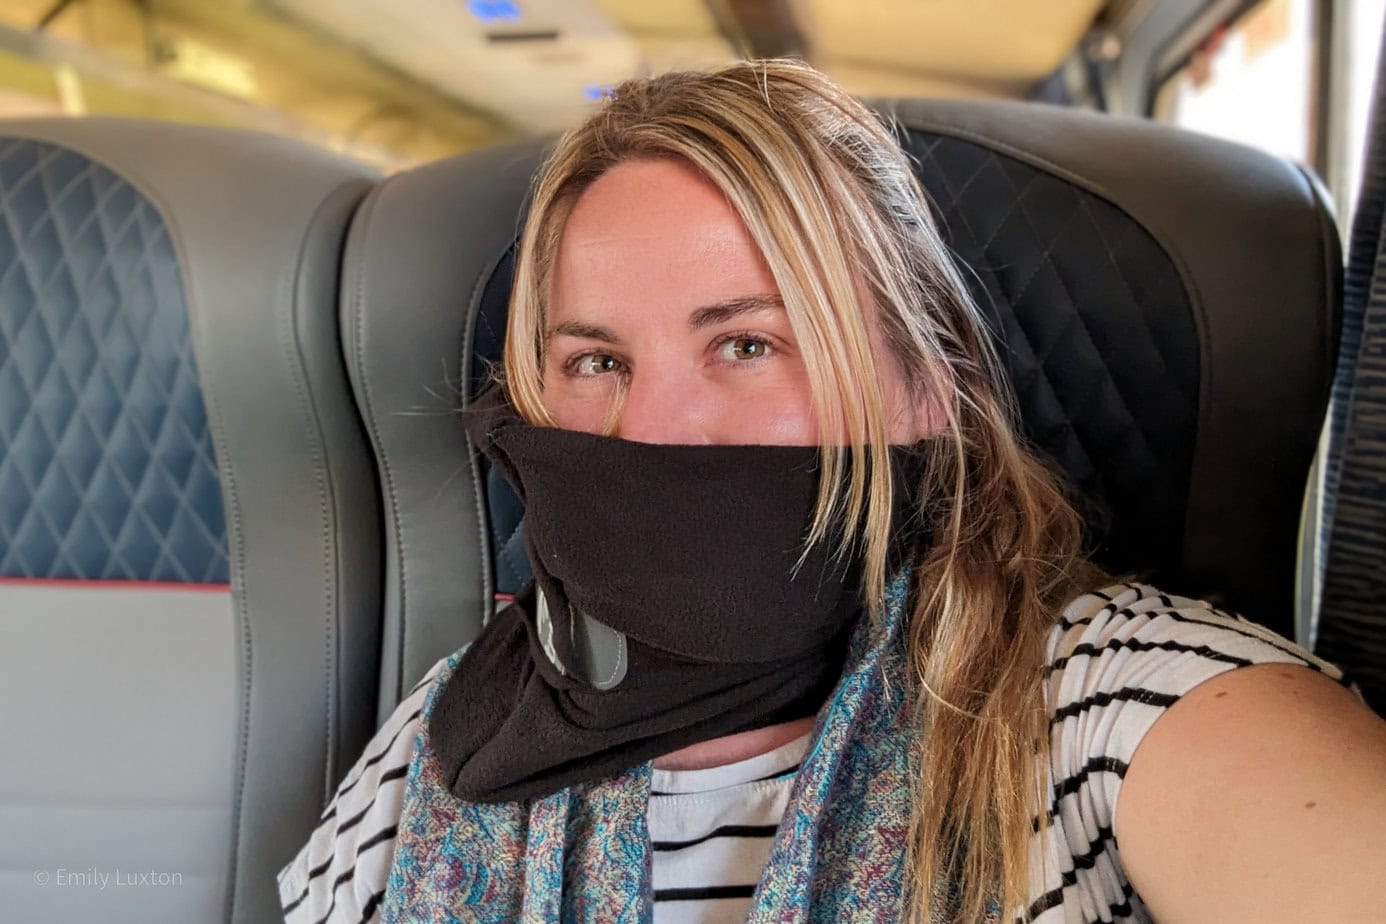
383;576;999;924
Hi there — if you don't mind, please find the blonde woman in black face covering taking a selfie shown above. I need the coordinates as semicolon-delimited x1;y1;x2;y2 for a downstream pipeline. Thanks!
280;61;1386;923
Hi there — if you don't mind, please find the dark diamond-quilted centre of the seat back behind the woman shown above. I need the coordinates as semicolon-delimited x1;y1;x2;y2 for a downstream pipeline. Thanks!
473;130;1199;590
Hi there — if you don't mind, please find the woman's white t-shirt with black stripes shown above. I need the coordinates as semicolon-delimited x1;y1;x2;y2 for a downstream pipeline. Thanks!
279;585;1342;924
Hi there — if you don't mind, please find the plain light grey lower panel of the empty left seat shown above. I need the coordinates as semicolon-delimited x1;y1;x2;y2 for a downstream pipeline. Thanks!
0;586;240;924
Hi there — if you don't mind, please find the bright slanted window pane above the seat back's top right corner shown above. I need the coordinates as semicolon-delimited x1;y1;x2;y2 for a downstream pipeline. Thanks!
1155;0;1318;163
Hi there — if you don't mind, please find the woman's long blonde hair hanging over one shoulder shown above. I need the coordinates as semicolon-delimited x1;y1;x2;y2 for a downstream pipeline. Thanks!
505;60;1092;921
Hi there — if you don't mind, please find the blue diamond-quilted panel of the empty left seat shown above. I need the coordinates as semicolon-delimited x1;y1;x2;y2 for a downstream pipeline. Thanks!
0;139;227;583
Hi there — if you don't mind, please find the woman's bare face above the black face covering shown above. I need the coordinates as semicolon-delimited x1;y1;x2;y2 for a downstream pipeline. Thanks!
543;161;923;446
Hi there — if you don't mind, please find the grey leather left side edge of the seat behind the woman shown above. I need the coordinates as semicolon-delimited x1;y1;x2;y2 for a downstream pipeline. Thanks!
342;145;541;720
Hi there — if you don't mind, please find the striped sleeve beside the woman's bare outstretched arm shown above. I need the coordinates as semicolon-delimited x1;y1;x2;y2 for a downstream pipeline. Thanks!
1020;583;1342;924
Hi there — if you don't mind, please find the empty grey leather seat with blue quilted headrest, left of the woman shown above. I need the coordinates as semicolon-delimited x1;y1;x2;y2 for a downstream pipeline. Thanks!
0;119;381;921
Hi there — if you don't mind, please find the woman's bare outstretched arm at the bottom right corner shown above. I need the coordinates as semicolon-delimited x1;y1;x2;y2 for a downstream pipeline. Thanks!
1116;665;1386;924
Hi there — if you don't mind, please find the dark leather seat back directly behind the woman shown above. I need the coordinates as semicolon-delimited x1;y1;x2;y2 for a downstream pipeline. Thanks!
345;101;1340;713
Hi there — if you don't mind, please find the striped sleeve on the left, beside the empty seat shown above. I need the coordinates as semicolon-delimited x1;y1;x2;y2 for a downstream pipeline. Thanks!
279;659;446;924
